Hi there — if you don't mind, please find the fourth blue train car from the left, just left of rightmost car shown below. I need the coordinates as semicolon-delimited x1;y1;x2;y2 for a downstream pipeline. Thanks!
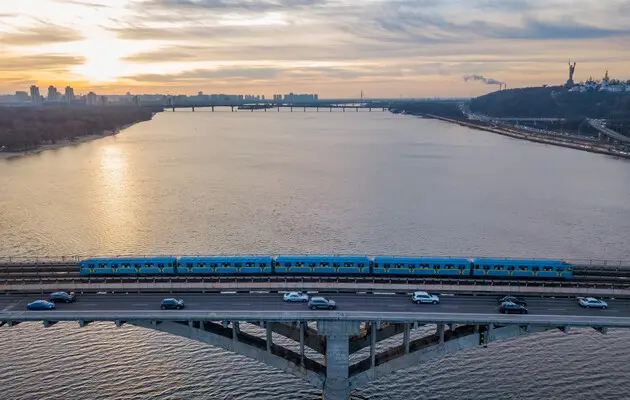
372;256;471;276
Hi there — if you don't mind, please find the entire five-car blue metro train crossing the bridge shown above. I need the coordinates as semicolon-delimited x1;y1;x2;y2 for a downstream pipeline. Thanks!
79;255;574;279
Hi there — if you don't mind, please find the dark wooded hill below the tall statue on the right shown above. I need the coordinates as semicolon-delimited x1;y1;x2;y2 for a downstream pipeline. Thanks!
470;86;630;120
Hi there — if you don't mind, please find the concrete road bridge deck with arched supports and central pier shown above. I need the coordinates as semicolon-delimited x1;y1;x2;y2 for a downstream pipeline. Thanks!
0;293;630;400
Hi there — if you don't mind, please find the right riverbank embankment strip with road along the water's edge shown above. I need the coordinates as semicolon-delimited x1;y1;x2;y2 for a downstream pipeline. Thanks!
420;114;630;159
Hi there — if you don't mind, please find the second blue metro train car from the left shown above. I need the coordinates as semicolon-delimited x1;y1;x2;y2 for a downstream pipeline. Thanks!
177;256;273;275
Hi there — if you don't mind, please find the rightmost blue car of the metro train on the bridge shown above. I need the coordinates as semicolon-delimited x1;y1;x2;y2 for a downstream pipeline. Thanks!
472;258;573;279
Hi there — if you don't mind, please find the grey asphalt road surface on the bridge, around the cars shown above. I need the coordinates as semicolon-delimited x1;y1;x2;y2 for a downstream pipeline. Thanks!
0;293;630;317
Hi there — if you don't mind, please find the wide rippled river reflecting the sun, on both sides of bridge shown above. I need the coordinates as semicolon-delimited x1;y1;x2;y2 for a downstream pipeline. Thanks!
0;112;630;400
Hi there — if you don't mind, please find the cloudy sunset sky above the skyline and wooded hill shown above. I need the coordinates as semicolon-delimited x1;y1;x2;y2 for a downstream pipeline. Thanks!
0;0;630;98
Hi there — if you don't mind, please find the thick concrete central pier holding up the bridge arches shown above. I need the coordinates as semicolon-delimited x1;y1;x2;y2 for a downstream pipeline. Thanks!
317;321;361;400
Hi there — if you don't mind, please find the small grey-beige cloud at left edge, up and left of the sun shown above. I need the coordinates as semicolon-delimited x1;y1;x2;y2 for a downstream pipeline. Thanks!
0;24;83;46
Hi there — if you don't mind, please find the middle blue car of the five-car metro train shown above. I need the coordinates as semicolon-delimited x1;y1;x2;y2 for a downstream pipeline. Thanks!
274;255;370;275
